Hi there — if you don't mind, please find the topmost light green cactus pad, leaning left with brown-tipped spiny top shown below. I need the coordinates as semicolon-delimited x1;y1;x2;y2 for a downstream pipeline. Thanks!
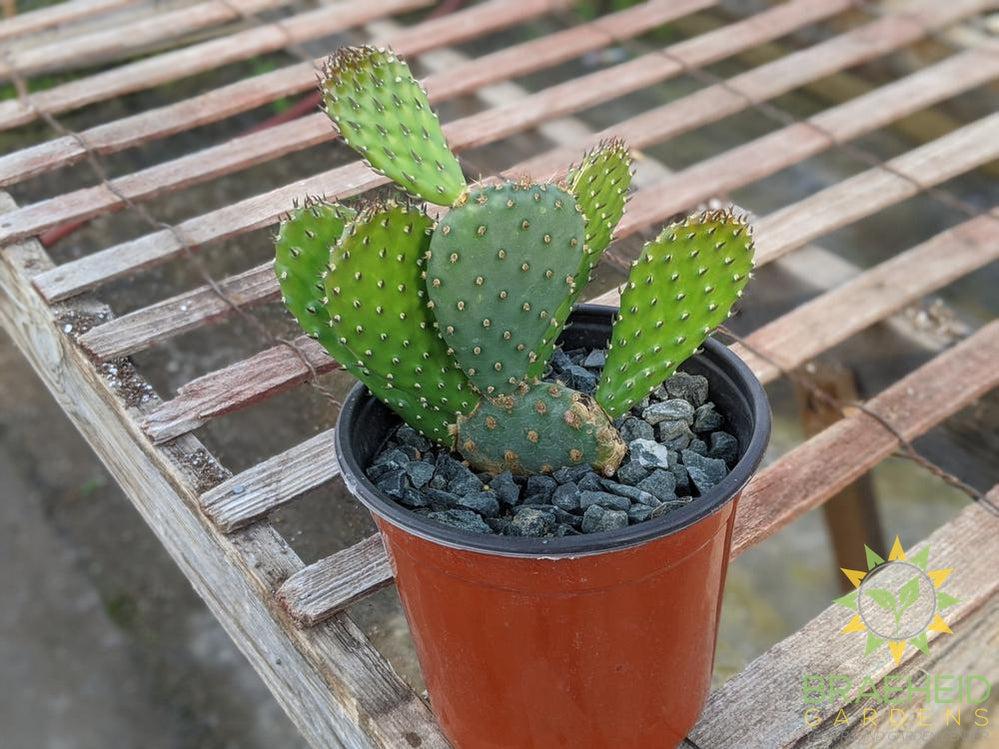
320;46;465;205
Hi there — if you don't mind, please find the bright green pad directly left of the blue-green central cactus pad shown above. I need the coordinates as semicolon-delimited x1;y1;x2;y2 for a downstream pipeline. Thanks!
324;203;478;444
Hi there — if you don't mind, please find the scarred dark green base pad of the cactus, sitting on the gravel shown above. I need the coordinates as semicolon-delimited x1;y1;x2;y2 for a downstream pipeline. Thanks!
457;382;626;476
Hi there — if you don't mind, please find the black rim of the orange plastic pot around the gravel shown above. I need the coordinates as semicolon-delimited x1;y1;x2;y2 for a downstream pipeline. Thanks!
334;304;771;558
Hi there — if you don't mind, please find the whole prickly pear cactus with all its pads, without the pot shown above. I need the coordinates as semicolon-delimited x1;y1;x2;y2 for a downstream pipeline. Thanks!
275;47;753;476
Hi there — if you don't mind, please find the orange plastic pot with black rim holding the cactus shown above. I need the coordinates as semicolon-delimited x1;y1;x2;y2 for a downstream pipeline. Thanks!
336;306;770;749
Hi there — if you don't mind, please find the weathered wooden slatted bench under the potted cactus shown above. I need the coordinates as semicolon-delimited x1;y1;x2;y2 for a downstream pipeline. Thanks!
0;0;999;749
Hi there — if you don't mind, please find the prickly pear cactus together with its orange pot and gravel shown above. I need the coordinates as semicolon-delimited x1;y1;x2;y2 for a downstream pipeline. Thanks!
275;47;769;748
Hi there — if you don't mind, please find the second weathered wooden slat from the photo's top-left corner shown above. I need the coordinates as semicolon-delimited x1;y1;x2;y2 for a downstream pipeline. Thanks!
0;0;291;79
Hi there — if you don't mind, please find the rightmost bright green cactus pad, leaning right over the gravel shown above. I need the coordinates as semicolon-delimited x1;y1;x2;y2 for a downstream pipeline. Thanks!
596;211;753;418
